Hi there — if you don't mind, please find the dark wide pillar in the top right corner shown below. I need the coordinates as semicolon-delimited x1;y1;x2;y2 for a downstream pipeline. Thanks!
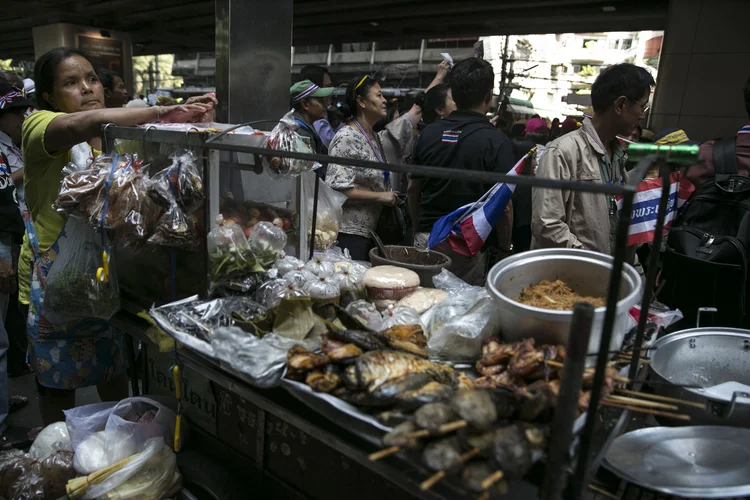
649;0;750;141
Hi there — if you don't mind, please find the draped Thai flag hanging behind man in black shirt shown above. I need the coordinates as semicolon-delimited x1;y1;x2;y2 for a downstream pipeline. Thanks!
427;154;529;257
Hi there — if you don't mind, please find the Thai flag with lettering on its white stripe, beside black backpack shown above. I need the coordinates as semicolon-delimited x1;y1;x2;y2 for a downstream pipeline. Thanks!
616;172;695;246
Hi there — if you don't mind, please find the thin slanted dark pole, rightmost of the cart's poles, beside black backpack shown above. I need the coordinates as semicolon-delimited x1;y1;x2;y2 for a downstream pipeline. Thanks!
628;162;677;382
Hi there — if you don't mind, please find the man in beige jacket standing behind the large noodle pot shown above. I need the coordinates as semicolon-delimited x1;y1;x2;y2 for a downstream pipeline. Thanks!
531;63;654;254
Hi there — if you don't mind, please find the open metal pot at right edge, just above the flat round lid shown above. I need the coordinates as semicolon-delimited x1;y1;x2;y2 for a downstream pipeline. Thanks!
649;328;750;427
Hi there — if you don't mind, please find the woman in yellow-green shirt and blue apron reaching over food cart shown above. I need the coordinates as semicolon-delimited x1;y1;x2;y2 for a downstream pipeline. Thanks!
18;48;216;425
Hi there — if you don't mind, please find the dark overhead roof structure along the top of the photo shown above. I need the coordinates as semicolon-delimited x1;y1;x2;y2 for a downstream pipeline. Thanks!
0;0;669;60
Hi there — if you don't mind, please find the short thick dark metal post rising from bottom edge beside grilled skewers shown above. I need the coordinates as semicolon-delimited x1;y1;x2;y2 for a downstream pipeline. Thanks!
541;302;594;500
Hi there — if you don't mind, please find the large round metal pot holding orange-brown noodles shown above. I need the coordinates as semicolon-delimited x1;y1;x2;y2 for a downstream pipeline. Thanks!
487;248;641;365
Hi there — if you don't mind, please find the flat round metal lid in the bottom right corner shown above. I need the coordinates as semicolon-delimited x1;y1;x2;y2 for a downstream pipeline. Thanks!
604;426;750;498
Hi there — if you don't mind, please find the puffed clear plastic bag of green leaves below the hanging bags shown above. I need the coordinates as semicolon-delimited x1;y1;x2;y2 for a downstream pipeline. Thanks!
207;215;263;281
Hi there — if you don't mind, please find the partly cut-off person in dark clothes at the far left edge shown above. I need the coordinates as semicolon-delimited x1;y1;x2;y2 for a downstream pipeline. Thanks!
0;81;31;444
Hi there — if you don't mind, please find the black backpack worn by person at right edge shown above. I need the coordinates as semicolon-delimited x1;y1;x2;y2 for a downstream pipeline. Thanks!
658;138;750;328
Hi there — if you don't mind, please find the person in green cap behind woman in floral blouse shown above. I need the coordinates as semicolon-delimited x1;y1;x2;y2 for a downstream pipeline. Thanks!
289;80;333;155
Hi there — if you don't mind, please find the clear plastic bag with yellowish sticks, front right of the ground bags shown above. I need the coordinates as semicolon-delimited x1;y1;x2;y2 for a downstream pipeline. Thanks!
83;438;181;500
